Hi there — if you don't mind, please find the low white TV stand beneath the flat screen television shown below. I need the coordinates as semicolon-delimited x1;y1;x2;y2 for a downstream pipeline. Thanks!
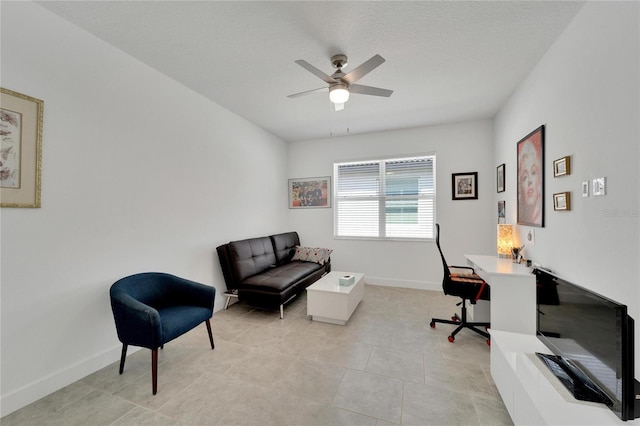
490;329;640;426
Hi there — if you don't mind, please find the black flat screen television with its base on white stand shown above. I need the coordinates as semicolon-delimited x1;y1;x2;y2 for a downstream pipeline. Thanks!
534;268;640;420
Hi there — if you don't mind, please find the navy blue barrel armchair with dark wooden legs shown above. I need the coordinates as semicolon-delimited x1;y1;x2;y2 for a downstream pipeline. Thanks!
110;272;216;395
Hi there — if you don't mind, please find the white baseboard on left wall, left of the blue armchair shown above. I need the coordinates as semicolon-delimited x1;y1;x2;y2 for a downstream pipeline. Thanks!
0;344;129;417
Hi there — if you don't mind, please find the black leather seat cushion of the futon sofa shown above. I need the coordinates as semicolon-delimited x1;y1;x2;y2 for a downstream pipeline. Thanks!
241;261;323;293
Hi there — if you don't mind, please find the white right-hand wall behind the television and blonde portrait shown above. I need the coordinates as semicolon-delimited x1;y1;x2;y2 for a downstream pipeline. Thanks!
495;2;640;362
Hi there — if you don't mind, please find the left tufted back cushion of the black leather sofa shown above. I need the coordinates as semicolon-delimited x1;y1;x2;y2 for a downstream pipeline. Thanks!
229;237;276;281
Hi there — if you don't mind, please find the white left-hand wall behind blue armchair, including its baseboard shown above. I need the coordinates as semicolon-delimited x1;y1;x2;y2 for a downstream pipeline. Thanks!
1;2;289;415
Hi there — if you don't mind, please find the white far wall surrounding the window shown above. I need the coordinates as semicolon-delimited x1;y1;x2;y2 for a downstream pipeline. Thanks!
289;121;497;290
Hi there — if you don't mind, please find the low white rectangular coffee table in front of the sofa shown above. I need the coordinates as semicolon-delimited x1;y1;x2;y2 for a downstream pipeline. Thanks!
307;271;364;325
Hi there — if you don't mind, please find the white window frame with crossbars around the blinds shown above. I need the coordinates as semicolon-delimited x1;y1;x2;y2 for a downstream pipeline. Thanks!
332;152;437;242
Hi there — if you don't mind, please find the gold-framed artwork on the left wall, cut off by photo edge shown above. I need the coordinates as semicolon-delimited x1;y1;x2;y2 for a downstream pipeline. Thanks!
0;88;44;208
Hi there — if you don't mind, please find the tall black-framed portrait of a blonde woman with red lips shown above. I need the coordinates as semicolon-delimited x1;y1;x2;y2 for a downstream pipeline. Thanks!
517;125;544;227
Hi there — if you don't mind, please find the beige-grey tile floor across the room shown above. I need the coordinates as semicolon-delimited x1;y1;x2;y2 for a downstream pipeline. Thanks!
0;285;513;426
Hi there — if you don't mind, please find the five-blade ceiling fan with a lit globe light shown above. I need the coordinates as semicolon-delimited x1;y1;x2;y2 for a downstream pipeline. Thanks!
288;55;393;111
